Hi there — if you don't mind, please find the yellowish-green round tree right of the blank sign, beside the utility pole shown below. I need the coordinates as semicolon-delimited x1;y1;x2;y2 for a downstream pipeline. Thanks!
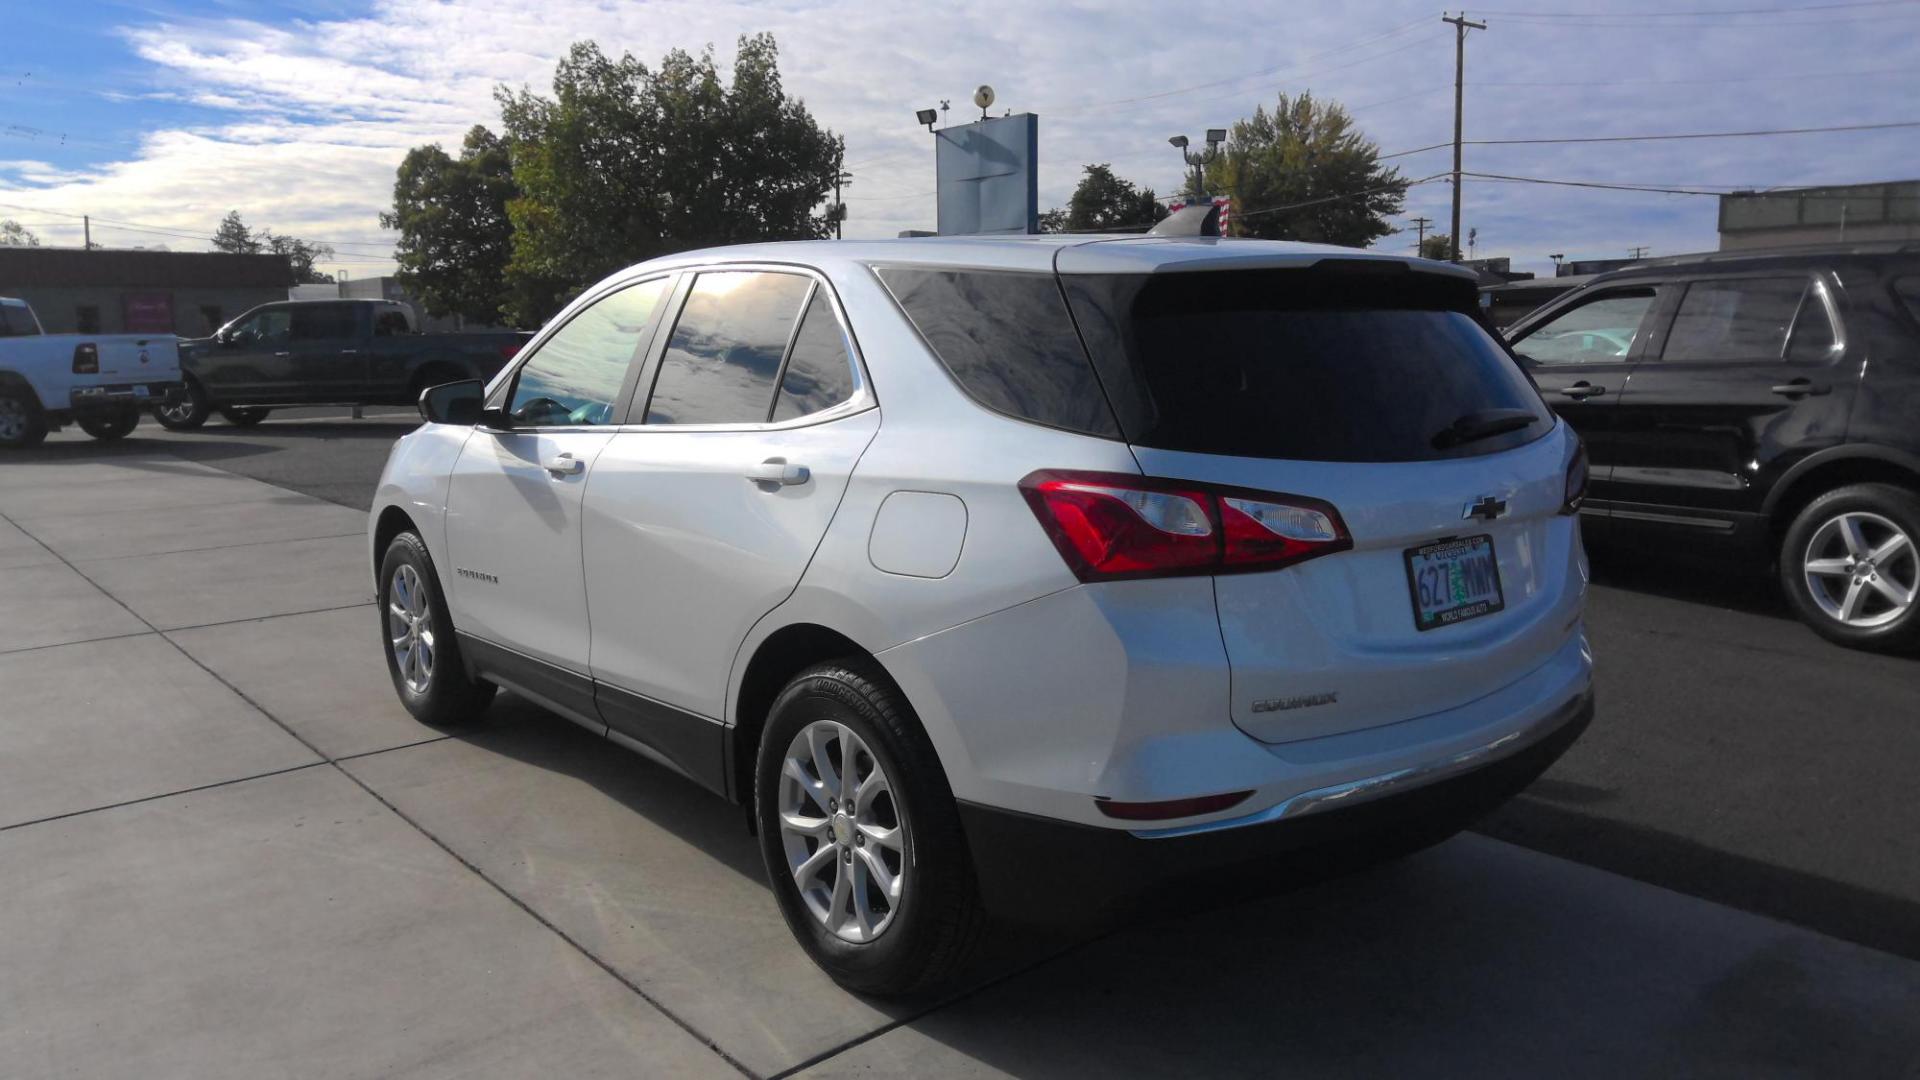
1188;94;1407;248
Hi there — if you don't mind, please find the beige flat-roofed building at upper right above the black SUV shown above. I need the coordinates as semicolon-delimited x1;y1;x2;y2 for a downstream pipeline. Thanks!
1720;181;1920;252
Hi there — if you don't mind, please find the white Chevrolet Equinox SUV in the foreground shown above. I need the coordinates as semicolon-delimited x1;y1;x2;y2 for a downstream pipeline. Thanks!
371;236;1592;994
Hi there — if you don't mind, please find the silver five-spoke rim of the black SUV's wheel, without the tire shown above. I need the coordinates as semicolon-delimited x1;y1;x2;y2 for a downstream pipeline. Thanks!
1801;509;1920;630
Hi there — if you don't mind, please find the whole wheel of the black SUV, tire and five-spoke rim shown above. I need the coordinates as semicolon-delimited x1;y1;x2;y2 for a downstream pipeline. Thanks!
1780;484;1920;651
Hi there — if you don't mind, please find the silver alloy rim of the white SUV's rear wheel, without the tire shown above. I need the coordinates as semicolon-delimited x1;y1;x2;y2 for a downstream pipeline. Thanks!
780;721;908;942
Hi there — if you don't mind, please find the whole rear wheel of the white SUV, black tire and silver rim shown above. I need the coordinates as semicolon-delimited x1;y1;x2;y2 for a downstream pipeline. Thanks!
755;661;987;997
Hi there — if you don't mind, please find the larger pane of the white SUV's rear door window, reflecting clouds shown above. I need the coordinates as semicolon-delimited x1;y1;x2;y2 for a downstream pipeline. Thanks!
647;271;814;425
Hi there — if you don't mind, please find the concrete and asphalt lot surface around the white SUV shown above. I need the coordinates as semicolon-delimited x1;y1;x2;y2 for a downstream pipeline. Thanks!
0;413;1920;1076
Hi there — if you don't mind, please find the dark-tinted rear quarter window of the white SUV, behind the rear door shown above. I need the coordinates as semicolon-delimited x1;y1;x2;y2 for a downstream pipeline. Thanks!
876;267;1119;438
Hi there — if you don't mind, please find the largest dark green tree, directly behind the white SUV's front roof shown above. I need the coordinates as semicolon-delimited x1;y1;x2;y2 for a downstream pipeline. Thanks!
495;35;845;323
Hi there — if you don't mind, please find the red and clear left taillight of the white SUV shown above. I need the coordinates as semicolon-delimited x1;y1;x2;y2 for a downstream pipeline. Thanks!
1020;469;1354;580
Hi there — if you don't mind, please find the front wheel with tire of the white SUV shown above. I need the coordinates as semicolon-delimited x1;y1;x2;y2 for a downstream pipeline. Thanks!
380;532;495;726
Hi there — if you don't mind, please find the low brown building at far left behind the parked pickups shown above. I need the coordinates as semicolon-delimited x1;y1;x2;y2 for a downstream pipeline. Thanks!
0;248;294;338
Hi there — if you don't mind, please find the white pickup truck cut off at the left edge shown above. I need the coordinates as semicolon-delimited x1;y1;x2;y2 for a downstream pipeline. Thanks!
0;296;180;450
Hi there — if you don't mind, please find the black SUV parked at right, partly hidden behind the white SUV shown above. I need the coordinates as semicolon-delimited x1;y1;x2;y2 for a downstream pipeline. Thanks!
1507;244;1920;650
